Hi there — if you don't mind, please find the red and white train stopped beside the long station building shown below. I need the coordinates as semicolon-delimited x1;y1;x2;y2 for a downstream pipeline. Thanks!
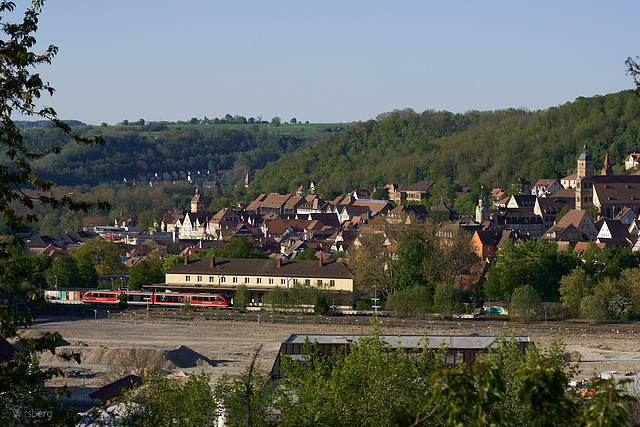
82;290;231;308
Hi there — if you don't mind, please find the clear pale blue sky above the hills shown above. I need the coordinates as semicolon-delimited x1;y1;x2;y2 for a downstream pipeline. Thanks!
19;0;640;124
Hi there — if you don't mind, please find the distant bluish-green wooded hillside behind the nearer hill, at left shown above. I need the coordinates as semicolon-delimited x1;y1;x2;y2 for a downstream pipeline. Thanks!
21;124;333;185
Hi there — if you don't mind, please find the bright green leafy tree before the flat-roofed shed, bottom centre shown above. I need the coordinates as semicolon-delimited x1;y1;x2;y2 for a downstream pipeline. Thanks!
273;330;441;426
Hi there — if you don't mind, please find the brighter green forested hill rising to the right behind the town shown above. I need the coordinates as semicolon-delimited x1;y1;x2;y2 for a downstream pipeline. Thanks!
251;91;640;201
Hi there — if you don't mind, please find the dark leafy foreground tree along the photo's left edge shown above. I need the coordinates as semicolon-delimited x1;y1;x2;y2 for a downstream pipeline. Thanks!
0;0;107;426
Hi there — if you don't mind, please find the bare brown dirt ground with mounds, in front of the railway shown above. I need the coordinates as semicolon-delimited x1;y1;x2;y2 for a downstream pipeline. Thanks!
26;315;640;408
